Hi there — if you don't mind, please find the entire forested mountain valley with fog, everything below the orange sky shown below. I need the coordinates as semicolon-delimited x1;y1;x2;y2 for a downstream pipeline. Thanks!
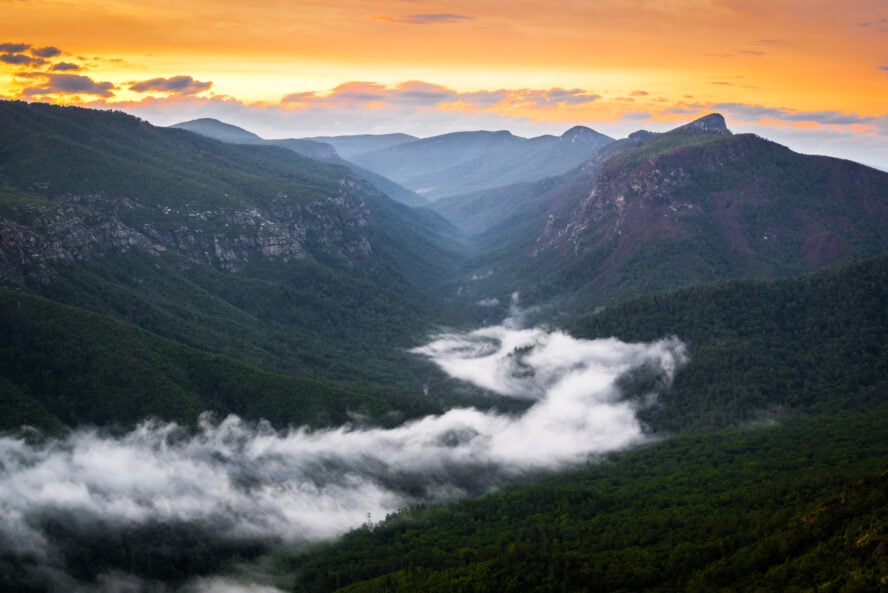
0;101;888;592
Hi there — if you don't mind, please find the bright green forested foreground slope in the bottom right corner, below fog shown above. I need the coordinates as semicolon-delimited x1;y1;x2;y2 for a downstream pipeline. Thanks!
279;405;888;593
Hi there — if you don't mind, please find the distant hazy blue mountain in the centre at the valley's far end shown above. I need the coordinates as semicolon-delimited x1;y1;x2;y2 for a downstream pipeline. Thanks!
350;126;612;200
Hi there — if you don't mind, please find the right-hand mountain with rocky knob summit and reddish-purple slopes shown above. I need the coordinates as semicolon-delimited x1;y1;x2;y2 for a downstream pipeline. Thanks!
458;114;888;311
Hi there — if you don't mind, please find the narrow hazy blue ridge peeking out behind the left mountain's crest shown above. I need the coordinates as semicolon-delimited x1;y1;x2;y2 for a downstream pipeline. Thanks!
170;118;426;206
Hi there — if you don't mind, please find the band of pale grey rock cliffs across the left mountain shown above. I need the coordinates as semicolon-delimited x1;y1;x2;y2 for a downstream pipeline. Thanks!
0;190;372;284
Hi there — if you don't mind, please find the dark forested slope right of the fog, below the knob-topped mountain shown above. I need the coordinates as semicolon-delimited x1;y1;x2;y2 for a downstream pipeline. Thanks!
571;257;888;431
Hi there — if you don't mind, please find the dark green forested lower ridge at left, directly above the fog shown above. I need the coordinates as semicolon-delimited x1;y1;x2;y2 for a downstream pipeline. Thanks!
0;289;389;430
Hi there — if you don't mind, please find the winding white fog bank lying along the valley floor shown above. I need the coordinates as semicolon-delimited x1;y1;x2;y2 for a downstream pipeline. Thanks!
0;325;686;590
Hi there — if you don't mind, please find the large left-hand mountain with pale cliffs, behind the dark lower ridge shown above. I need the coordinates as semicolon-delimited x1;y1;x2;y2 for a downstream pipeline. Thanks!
0;102;472;425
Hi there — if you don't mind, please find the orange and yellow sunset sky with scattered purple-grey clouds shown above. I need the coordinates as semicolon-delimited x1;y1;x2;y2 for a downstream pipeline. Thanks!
0;0;888;170
